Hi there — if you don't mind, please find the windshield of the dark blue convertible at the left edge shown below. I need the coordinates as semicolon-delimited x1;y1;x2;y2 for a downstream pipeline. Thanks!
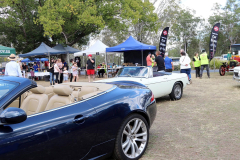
0;80;18;100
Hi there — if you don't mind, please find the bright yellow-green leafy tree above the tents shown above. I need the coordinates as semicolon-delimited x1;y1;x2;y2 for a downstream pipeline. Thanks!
36;0;158;45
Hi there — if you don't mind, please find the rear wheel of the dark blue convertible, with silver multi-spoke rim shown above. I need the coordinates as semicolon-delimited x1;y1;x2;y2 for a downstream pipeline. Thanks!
113;114;149;160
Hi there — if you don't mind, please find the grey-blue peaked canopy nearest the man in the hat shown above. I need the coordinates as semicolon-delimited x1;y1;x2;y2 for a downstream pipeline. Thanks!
19;42;67;57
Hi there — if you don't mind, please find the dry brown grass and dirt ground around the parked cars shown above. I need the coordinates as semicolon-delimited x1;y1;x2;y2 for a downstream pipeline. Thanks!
38;72;240;160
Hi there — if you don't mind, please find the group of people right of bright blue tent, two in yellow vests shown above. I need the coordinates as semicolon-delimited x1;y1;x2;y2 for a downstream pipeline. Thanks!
146;49;210;84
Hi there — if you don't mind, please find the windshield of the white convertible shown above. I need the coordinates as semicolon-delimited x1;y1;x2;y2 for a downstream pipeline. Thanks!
117;67;148;77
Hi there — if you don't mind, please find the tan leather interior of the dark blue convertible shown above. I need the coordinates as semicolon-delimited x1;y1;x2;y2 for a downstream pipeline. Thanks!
8;82;113;116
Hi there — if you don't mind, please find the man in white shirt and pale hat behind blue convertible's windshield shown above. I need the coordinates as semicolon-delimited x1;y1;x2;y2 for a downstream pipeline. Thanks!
5;54;22;77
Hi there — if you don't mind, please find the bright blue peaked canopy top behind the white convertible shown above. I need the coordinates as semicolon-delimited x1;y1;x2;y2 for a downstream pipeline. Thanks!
106;36;157;52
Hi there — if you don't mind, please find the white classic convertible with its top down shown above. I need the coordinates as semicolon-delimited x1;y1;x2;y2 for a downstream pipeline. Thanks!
96;66;189;100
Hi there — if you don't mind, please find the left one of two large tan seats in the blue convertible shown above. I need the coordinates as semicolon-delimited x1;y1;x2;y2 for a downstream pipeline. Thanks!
21;85;48;115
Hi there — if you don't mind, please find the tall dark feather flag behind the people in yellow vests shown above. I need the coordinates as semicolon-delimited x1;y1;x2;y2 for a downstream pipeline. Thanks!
209;23;220;61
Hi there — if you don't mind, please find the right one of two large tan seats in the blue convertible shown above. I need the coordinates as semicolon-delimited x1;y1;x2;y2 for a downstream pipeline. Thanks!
45;85;74;111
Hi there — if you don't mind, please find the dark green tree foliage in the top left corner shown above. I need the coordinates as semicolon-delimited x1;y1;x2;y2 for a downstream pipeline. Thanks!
0;0;51;53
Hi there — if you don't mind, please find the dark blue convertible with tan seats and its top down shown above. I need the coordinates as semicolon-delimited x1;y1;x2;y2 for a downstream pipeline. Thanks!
0;76;156;160
